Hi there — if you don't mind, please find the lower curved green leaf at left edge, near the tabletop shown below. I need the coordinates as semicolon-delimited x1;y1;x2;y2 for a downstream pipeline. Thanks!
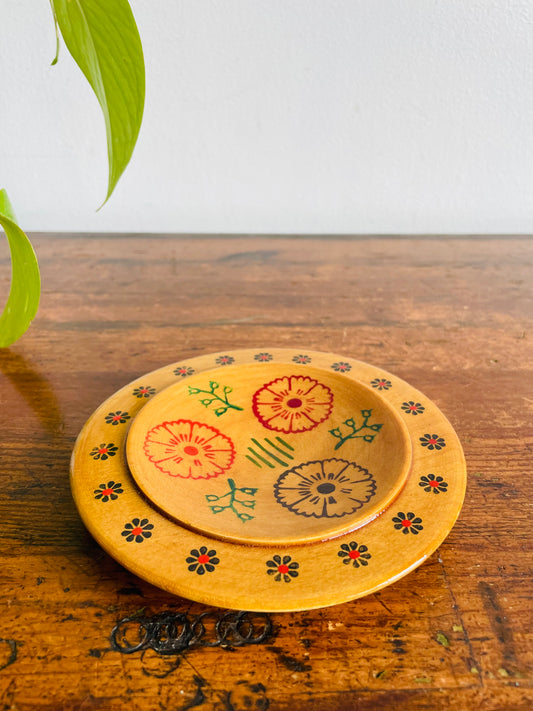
0;190;41;348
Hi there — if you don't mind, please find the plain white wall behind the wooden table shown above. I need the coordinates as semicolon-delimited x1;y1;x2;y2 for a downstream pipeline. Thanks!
0;0;533;233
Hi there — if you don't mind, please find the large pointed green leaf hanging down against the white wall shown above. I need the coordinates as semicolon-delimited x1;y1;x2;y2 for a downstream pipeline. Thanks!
51;0;145;204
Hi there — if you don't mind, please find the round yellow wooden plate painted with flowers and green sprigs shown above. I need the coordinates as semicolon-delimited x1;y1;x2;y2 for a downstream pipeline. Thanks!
71;349;466;611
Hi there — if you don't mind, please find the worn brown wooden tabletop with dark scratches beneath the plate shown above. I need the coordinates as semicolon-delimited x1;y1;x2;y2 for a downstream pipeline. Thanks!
0;234;533;711
